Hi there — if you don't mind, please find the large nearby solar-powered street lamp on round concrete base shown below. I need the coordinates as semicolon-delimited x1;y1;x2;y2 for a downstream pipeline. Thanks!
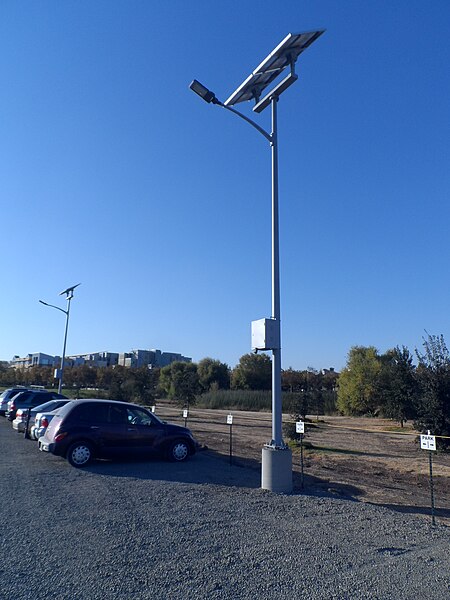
189;30;324;493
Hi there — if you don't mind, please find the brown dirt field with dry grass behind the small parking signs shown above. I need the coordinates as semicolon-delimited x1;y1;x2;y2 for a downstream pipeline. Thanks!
156;404;450;525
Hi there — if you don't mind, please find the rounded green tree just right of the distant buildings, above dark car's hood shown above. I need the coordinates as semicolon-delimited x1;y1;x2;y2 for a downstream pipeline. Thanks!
159;361;200;406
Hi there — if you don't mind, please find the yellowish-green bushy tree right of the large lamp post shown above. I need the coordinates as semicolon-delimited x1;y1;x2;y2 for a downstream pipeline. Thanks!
337;346;381;415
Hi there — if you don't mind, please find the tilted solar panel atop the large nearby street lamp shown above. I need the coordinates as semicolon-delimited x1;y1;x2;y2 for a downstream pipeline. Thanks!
224;30;325;106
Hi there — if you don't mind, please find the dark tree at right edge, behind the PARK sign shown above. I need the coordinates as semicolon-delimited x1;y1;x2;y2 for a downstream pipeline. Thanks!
415;334;450;448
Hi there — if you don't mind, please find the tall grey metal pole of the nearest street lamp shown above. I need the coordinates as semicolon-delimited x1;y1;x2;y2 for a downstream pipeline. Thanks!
270;96;284;448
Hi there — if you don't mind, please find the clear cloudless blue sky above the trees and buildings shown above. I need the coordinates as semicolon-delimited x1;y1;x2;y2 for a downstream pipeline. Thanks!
0;0;450;369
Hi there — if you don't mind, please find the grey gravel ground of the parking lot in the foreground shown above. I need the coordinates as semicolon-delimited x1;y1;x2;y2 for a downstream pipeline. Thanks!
0;419;450;600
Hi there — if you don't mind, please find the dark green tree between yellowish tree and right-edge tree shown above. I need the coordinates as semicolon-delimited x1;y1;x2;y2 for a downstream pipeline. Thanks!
375;346;418;427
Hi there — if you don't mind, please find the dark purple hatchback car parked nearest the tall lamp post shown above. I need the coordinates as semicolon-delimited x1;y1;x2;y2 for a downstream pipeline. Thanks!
38;399;199;467
